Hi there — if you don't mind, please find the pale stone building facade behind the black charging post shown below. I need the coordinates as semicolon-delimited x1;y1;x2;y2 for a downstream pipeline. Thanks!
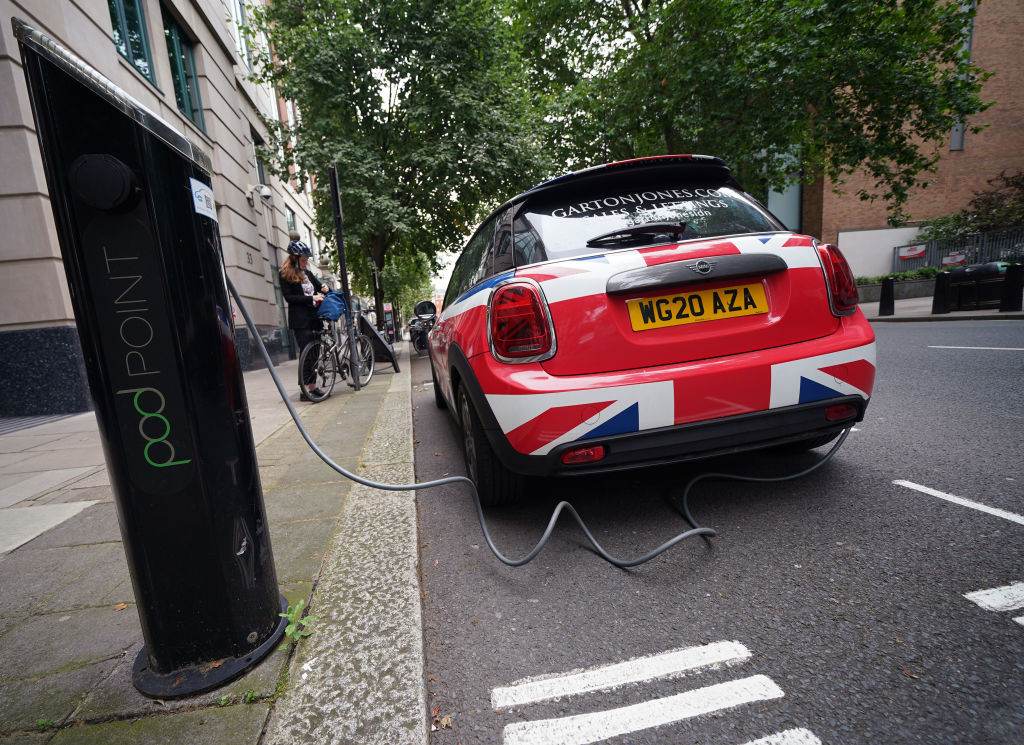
0;0;322;417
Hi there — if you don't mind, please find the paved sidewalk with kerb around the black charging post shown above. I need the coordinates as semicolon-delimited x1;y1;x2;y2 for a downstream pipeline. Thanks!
0;352;426;745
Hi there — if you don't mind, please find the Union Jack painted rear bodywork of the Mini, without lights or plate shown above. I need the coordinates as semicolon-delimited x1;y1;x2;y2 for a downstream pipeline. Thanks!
430;154;874;503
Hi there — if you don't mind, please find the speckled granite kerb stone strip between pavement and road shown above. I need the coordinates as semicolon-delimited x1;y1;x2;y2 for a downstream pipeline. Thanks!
262;348;428;745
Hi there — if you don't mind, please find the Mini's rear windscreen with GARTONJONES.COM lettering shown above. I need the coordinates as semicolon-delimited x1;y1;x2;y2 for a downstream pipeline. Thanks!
513;168;784;266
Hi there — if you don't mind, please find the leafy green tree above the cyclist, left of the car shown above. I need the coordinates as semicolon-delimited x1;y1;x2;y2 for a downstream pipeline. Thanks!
250;0;547;319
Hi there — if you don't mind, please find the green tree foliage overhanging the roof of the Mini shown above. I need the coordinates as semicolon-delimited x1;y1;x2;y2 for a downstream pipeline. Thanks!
515;0;986;213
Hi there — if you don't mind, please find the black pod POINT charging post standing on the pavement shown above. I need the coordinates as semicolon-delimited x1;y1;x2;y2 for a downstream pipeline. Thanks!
13;18;286;698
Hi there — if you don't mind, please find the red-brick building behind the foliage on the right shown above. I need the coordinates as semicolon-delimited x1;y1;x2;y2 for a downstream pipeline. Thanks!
769;0;1024;275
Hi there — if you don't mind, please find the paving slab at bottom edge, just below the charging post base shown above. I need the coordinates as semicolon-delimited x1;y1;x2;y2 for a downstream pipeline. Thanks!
50;703;268;745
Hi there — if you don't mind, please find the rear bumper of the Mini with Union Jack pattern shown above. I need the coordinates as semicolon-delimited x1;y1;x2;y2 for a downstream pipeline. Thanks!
450;311;874;475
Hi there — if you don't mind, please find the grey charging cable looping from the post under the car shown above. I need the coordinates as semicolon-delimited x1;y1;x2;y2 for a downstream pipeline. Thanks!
225;275;850;569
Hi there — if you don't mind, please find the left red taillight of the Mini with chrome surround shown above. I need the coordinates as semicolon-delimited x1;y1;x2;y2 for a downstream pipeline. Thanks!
487;279;555;362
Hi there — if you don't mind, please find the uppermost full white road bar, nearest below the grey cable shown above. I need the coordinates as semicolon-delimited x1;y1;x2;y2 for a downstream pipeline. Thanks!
490;642;751;709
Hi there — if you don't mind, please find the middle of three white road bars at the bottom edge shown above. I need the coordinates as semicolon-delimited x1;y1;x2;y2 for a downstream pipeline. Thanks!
503;675;785;745
